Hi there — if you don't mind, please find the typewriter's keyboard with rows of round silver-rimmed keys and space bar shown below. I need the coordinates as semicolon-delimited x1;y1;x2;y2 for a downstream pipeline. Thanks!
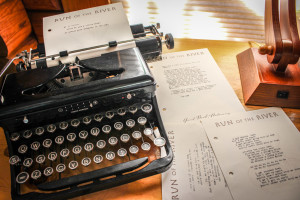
9;103;166;190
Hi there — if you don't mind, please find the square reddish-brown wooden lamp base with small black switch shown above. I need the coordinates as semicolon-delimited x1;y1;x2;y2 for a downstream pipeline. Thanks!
237;48;300;108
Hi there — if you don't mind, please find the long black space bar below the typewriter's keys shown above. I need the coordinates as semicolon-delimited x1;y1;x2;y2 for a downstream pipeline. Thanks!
37;157;148;191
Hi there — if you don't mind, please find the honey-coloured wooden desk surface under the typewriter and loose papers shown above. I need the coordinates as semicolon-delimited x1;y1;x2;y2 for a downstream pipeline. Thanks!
0;39;300;200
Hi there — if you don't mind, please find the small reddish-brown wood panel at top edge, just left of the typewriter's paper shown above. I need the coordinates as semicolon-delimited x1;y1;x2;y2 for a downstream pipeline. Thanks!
23;0;62;11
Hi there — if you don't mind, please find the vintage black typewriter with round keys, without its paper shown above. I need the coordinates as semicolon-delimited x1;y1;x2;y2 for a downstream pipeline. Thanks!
0;24;174;200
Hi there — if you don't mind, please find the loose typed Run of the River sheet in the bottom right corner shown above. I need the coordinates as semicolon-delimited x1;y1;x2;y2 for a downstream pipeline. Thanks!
203;108;300;200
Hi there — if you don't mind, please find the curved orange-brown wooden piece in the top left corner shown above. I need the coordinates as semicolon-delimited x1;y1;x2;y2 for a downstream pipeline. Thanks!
0;0;31;54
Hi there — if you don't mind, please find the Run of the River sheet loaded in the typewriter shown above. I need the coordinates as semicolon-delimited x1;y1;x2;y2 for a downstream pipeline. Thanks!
43;3;135;56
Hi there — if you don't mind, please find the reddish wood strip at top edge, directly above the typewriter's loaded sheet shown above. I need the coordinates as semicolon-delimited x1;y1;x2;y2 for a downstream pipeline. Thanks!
61;0;110;12
